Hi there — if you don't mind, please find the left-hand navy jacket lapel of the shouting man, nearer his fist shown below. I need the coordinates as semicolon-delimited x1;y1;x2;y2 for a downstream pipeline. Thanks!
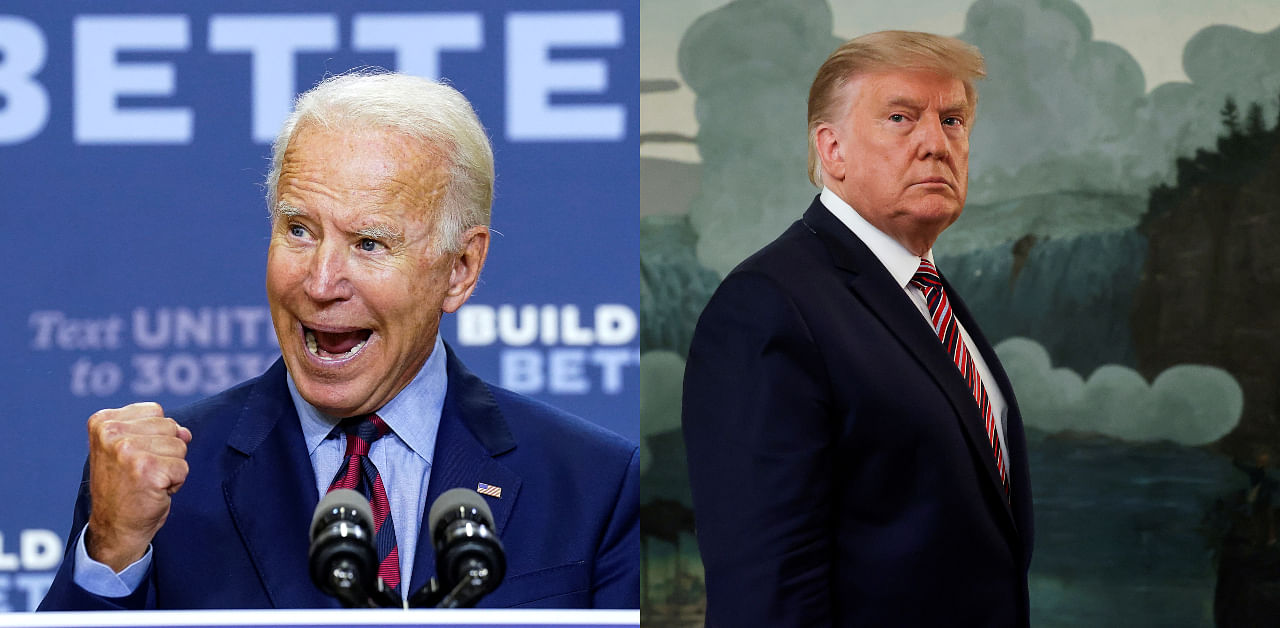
223;361;338;608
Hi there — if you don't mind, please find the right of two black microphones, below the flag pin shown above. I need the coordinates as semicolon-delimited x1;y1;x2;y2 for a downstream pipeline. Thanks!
426;489;507;609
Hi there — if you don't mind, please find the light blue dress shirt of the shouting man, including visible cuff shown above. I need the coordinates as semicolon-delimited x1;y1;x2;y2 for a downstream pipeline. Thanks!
74;334;449;599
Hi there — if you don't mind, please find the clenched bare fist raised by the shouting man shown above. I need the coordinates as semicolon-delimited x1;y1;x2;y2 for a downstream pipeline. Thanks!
84;403;191;572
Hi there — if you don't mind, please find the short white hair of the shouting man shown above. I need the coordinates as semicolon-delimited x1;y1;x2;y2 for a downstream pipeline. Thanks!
266;69;494;252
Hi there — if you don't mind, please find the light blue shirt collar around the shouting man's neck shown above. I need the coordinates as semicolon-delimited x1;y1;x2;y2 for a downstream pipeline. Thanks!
287;334;449;464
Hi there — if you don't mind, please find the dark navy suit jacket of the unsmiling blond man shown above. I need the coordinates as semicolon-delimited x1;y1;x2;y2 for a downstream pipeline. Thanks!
684;201;1032;628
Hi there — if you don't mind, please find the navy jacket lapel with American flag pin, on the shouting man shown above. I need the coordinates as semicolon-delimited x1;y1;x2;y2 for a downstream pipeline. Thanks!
410;343;521;593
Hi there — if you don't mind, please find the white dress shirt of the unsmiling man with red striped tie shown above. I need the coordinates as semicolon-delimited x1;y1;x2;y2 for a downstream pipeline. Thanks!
819;187;1009;477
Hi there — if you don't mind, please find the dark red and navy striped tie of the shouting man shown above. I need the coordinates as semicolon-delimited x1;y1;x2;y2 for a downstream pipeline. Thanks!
329;414;399;595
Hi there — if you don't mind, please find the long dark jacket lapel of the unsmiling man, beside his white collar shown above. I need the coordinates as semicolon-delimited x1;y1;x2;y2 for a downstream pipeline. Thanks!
804;200;1016;531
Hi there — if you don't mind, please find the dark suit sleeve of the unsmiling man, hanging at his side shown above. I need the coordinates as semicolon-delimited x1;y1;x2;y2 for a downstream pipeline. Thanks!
682;272;835;628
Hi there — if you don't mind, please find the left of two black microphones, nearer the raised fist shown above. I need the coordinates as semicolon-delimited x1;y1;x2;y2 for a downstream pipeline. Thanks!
307;489;398;608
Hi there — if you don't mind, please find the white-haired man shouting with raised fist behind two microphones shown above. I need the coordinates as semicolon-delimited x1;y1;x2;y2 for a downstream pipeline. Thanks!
41;73;639;610
